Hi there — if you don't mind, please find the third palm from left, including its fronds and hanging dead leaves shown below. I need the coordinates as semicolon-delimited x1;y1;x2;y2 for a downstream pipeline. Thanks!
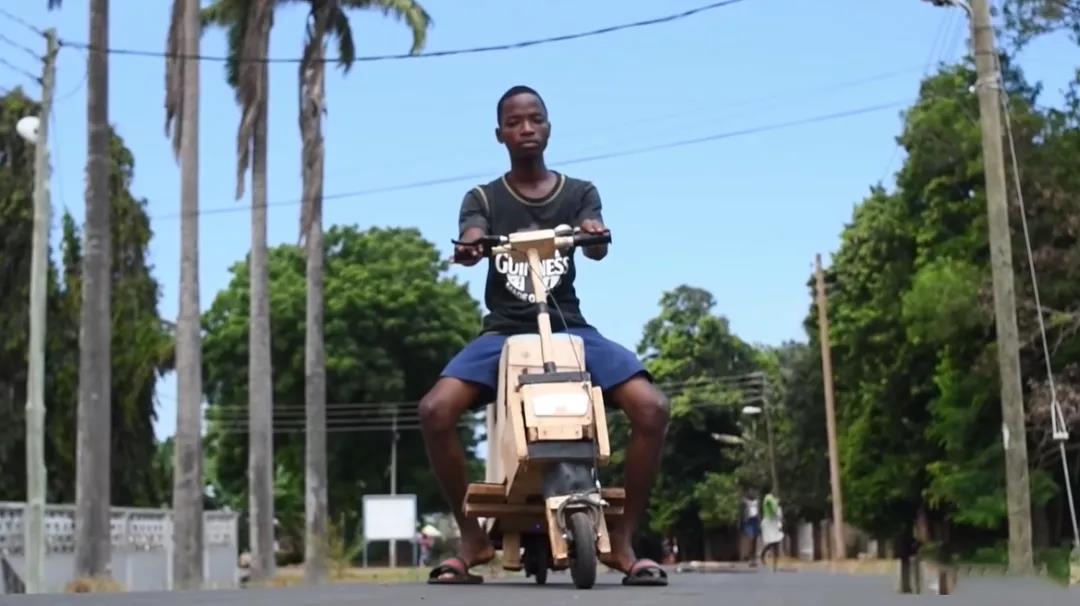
202;0;274;581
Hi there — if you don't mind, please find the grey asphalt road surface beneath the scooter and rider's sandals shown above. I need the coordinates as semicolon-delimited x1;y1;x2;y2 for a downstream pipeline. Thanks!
0;571;1080;606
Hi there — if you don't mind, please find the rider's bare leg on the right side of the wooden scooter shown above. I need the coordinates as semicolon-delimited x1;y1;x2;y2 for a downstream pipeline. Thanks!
604;376;670;573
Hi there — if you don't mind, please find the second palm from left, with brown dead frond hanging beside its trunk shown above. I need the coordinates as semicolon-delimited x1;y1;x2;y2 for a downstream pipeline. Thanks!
165;0;203;589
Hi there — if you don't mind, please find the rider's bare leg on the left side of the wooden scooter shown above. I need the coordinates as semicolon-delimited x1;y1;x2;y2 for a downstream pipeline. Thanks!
419;377;495;576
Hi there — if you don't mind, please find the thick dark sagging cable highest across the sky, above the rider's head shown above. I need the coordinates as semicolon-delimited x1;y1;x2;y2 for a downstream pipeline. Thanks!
52;0;745;64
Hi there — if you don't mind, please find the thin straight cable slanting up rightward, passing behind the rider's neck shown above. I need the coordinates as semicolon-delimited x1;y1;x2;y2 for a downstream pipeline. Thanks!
152;99;912;220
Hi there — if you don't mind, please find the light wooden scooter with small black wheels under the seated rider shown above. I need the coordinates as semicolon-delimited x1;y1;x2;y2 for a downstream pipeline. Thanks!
456;225;625;589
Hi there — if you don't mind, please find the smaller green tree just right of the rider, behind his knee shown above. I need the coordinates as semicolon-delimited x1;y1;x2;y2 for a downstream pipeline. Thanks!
605;285;767;557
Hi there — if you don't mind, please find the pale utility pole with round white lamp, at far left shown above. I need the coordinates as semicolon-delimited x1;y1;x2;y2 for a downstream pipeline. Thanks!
23;29;59;593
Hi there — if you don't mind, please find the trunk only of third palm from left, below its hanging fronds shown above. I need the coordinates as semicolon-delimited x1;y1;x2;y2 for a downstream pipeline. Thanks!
247;68;274;580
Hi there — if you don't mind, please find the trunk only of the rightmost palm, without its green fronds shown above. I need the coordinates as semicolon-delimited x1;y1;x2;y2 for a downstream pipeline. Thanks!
300;17;328;584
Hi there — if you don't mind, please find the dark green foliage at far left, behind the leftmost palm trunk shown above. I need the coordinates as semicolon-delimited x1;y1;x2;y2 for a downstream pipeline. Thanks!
0;90;172;507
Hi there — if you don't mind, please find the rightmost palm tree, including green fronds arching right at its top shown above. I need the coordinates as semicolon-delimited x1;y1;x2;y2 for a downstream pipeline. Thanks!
299;0;431;583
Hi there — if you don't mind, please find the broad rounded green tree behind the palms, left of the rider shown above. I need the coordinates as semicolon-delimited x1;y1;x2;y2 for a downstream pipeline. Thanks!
203;227;481;553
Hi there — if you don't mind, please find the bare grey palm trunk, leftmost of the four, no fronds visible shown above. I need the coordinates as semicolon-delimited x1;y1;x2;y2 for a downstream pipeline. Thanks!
75;0;112;577
